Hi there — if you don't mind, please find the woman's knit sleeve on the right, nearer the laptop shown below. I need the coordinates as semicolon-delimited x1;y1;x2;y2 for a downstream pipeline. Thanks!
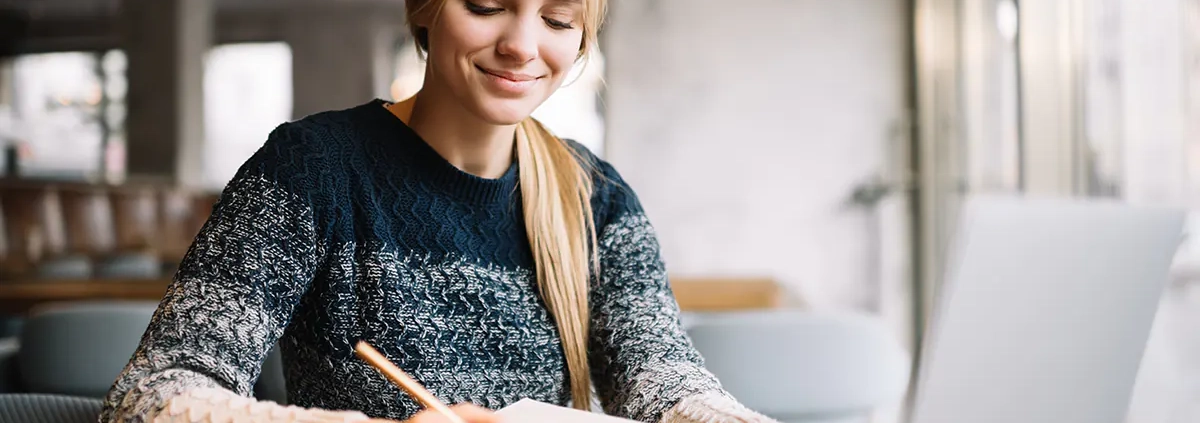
589;162;774;423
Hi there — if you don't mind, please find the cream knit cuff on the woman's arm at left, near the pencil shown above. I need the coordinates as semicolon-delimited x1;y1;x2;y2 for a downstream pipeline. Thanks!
148;388;370;423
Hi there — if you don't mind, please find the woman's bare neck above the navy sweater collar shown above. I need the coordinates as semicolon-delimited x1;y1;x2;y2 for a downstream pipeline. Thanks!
390;89;516;179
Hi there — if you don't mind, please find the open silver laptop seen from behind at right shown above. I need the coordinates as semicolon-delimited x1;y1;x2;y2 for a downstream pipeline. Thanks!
912;197;1184;423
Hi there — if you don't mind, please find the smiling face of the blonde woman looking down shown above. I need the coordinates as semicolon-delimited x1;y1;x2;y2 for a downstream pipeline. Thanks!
414;0;584;125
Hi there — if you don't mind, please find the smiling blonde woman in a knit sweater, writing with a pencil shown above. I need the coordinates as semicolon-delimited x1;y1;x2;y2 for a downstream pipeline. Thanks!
102;0;769;423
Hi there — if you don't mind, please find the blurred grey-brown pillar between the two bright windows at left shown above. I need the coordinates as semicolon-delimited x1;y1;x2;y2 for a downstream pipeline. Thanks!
121;0;214;186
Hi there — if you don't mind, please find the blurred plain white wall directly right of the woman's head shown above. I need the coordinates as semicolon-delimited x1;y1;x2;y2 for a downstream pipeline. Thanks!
604;0;908;306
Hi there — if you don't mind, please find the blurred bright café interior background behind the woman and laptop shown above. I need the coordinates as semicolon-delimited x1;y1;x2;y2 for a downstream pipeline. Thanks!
0;0;1200;423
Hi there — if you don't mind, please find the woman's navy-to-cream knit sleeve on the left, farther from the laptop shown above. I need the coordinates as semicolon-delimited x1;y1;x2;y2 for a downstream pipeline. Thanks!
100;125;364;422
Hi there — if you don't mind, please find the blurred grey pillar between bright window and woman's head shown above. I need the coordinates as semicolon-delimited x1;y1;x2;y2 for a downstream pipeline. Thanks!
287;11;404;118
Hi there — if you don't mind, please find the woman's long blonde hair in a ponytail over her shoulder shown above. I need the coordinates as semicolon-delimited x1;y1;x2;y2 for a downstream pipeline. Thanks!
406;0;607;410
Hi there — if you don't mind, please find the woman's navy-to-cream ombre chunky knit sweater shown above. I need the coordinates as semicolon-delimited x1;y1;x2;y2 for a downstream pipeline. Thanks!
101;100;766;422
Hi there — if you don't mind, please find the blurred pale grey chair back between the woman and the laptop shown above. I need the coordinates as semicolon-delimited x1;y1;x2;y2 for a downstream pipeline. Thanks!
685;310;910;423
